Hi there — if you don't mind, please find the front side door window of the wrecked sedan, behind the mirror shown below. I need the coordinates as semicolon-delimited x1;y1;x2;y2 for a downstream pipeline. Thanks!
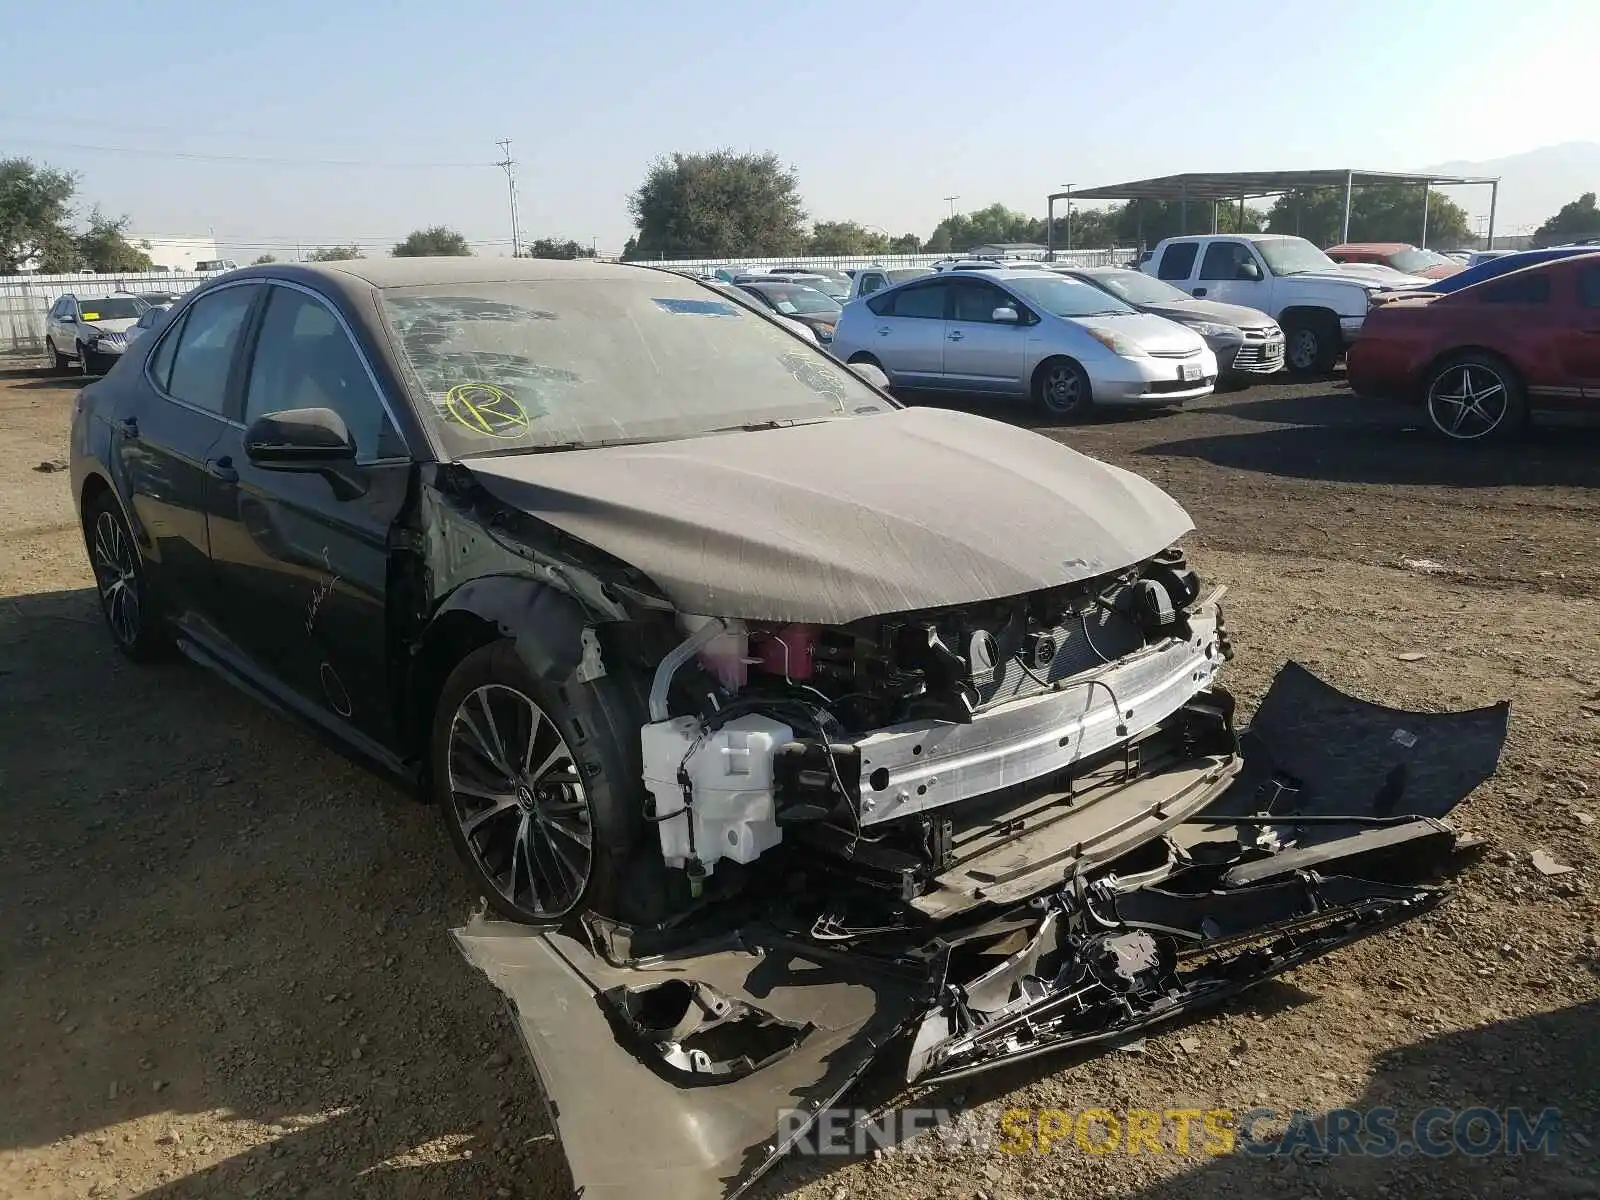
245;288;405;461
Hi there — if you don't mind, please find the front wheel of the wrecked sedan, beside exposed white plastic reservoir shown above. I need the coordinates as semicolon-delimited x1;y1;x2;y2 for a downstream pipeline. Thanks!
430;640;643;926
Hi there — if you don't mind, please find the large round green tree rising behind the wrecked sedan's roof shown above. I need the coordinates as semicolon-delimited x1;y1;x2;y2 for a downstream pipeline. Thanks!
624;150;806;259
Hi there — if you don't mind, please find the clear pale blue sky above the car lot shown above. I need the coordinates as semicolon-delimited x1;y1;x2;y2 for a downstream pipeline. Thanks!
0;0;1600;258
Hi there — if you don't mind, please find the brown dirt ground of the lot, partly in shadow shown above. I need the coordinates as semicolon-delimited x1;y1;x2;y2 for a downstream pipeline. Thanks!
0;371;1600;1200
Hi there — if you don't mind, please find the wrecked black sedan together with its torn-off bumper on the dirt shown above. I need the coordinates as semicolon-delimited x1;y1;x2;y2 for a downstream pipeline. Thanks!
72;259;1507;1197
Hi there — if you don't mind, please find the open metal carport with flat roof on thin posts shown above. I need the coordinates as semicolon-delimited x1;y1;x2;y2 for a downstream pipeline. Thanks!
1045;170;1499;250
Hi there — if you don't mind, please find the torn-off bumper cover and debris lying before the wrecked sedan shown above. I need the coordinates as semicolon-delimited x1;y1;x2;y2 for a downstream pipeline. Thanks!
454;664;1509;1200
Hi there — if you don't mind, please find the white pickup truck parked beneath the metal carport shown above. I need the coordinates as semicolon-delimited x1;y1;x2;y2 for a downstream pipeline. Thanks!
1139;234;1427;374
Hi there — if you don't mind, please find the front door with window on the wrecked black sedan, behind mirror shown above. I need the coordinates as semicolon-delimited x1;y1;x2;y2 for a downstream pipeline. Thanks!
211;283;413;749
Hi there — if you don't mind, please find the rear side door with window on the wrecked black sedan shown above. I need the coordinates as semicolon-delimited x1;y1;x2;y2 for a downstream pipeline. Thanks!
112;285;261;630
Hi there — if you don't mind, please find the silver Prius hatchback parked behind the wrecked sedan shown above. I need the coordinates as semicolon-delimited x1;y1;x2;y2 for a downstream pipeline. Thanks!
832;267;1218;419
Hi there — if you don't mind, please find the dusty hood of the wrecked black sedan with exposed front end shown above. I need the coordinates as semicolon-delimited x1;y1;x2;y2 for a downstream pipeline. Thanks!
462;409;1195;624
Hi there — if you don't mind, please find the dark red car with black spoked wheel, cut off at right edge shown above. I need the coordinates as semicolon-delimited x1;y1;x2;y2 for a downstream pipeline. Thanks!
1347;253;1600;442
